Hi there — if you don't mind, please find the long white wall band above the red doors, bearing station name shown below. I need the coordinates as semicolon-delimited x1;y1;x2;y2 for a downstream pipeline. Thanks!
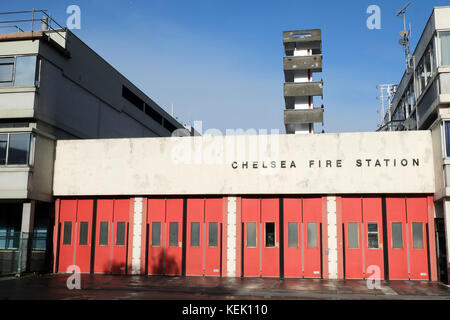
54;131;435;196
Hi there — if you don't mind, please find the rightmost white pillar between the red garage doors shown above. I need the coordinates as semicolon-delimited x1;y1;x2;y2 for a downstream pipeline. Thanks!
327;196;338;279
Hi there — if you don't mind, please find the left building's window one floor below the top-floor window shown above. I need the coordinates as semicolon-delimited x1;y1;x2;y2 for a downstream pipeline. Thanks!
0;133;32;166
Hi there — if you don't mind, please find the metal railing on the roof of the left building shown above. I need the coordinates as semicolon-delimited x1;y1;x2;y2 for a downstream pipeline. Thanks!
0;9;66;46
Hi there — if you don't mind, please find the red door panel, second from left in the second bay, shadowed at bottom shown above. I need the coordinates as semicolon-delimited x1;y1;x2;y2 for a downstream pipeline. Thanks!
165;199;183;275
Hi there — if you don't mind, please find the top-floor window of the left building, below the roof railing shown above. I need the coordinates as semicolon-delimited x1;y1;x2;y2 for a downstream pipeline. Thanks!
0;56;37;87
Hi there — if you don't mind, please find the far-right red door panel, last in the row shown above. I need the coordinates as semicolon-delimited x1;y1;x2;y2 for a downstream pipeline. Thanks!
406;197;429;280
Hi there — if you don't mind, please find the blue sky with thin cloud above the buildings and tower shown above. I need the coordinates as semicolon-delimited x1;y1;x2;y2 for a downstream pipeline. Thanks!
0;0;450;132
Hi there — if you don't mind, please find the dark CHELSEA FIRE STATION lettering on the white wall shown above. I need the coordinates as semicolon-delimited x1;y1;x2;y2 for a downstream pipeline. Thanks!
231;158;420;169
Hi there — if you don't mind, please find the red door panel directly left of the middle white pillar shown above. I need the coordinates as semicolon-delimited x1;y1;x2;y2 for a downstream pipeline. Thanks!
205;198;223;276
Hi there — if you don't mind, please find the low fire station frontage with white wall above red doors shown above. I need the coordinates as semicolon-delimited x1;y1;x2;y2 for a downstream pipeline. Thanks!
53;131;445;281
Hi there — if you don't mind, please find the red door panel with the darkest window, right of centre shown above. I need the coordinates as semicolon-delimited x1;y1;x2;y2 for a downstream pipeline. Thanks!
261;199;280;277
